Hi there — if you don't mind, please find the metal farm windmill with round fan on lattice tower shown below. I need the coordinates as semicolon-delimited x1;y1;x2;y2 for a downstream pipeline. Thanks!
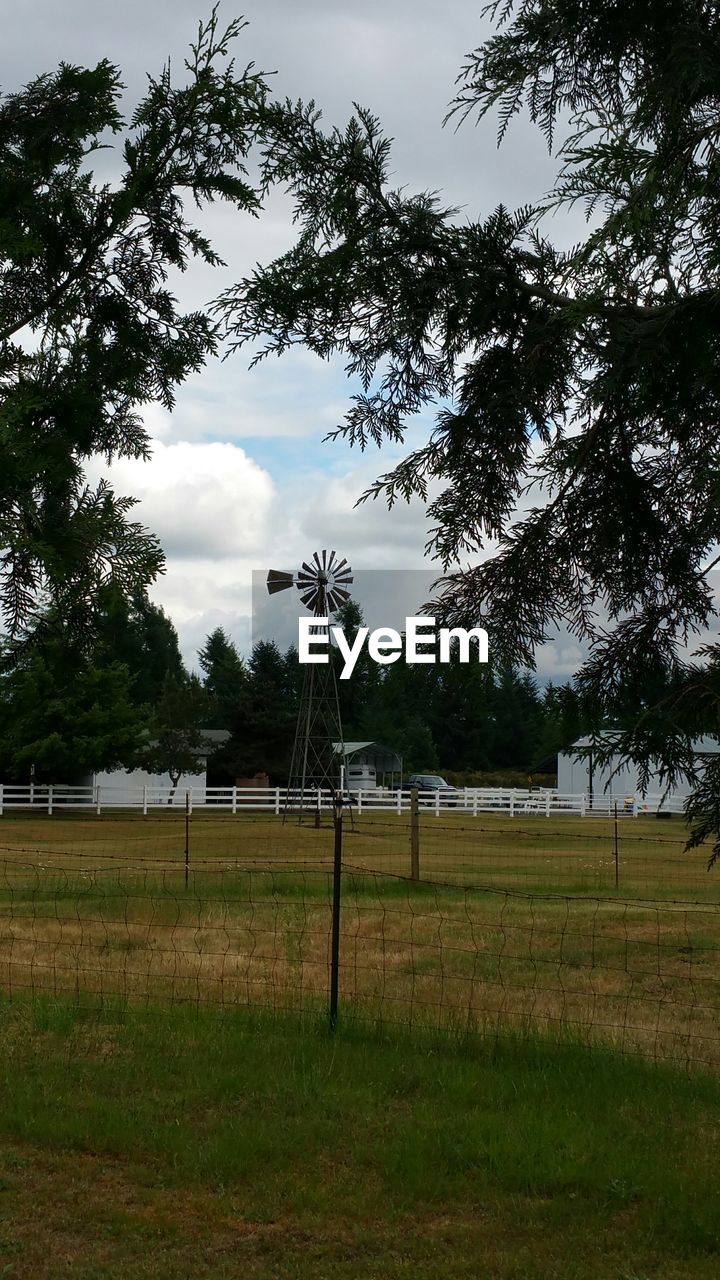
268;550;352;815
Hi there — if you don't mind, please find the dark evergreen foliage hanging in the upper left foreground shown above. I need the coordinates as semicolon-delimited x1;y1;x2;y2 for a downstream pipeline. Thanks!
0;10;265;644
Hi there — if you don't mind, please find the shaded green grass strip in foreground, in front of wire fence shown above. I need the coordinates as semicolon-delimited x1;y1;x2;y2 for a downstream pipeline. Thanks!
0;998;720;1280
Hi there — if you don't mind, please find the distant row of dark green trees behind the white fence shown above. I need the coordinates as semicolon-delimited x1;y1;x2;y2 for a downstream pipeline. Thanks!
0;585;584;785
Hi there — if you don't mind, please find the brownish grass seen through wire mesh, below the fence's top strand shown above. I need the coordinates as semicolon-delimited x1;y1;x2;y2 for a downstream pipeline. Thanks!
0;839;720;1068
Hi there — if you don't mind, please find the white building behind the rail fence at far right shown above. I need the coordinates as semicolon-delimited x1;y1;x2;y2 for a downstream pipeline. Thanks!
557;733;720;803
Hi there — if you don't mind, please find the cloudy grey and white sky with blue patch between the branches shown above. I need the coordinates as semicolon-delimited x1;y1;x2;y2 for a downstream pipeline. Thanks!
7;0;582;676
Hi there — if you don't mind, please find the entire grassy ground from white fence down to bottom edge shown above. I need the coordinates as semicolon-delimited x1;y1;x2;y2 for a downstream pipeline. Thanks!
0;814;720;1280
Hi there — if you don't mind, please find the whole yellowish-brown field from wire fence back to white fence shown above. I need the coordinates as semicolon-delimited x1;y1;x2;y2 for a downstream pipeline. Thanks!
0;814;720;1068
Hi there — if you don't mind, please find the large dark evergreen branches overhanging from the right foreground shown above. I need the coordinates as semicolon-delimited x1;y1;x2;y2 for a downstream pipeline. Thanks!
223;0;720;852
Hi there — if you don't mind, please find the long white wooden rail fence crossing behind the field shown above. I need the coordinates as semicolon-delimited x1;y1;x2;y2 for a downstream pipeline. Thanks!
0;783;683;818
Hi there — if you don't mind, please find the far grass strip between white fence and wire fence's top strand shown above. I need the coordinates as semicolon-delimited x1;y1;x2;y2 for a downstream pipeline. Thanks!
0;809;707;902
